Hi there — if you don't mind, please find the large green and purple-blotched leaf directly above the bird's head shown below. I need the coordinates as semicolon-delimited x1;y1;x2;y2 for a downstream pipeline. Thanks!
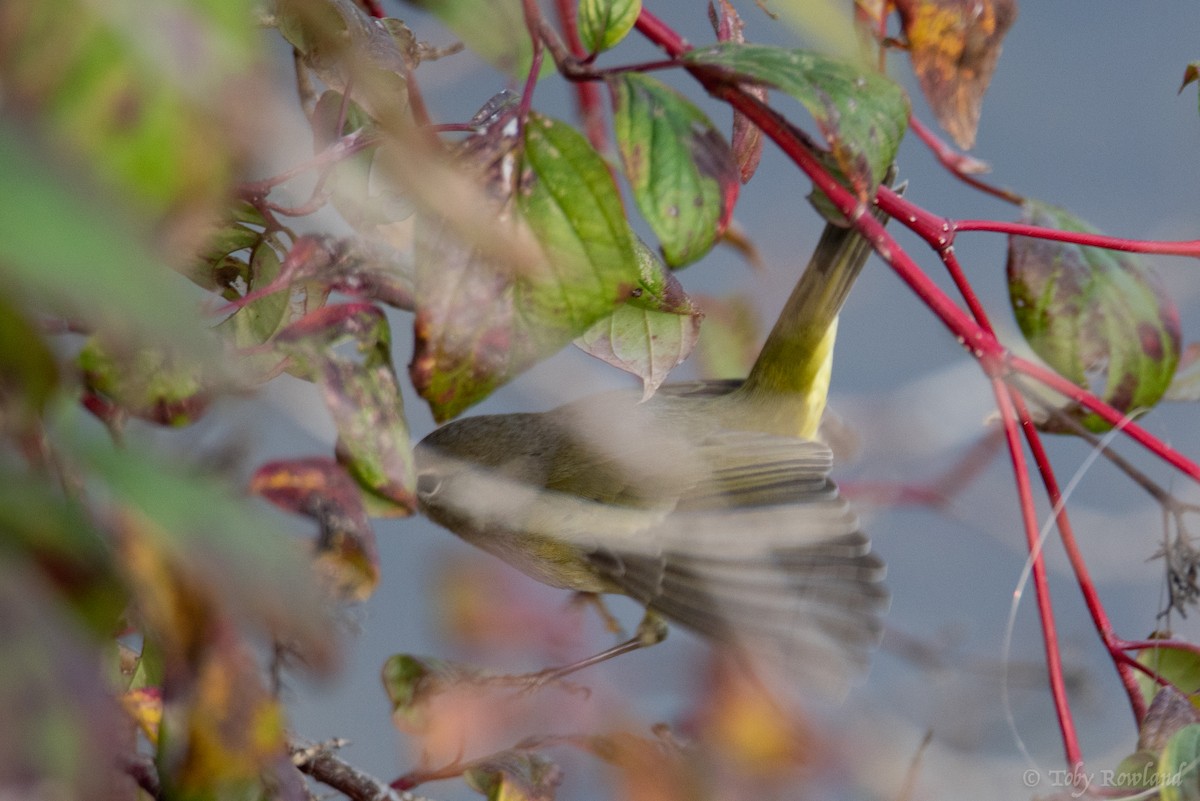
409;113;640;421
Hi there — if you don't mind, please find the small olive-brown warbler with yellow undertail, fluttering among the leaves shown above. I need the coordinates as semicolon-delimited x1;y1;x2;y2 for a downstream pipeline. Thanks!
415;195;888;693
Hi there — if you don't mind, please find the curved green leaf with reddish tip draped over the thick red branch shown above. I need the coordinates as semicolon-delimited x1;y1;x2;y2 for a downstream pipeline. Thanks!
683;42;908;199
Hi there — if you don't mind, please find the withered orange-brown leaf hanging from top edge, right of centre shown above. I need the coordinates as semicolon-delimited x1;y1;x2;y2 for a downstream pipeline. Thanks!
895;0;1016;150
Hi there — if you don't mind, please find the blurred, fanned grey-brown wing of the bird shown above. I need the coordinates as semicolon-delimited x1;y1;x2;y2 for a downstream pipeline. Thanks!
576;432;888;693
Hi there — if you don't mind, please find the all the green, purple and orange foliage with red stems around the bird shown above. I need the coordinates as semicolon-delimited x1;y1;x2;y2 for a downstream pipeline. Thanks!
0;0;1200;799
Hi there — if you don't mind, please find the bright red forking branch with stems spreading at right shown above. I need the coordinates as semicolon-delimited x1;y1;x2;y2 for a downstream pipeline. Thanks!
637;3;1200;772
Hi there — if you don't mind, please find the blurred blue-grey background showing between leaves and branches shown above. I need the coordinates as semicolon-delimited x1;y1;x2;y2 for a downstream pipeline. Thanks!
169;0;1200;799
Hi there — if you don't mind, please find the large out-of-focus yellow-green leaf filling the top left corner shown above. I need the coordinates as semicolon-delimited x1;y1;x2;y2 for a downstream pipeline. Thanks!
0;0;260;230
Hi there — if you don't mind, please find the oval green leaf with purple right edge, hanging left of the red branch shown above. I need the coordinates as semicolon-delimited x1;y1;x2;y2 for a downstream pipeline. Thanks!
608;73;739;266
